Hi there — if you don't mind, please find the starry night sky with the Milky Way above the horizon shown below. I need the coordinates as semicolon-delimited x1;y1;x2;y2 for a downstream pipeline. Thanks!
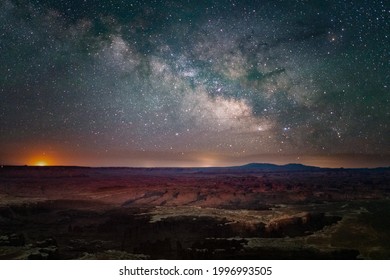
0;0;390;167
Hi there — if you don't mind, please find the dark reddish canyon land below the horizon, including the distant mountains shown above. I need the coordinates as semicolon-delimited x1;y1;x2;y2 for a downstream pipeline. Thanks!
0;164;390;259
